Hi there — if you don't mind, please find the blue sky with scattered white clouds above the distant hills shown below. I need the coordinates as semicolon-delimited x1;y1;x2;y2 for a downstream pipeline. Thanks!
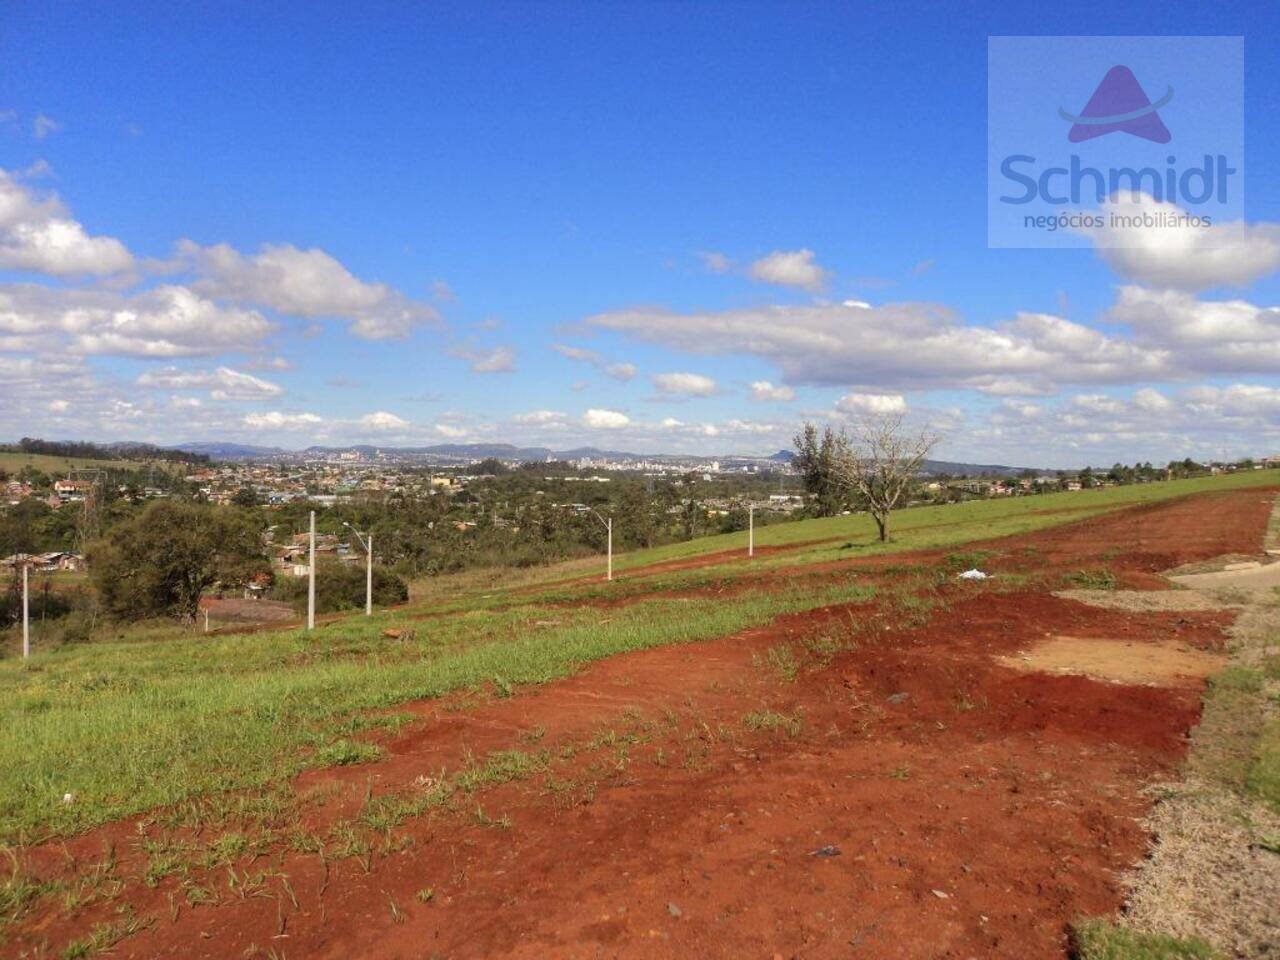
0;3;1280;466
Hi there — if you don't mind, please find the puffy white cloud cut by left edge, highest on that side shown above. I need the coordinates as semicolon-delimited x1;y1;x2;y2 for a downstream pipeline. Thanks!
0;170;133;276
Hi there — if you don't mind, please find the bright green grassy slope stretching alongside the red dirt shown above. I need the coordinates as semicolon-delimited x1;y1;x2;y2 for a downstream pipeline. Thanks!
0;472;1276;841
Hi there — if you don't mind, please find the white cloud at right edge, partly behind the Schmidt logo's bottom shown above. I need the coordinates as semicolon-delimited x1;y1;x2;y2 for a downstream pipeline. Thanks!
1089;193;1280;291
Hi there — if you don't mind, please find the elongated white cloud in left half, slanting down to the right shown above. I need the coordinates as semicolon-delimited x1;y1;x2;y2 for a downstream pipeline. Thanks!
177;241;439;340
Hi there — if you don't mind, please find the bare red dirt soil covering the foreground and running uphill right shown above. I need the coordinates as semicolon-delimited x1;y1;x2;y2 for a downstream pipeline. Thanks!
5;490;1271;960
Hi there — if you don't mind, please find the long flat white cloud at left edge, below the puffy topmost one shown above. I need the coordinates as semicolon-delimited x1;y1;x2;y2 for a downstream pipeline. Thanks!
0;284;271;357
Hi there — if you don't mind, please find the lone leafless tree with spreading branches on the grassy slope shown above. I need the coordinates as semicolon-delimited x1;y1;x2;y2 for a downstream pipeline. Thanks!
837;413;942;543
